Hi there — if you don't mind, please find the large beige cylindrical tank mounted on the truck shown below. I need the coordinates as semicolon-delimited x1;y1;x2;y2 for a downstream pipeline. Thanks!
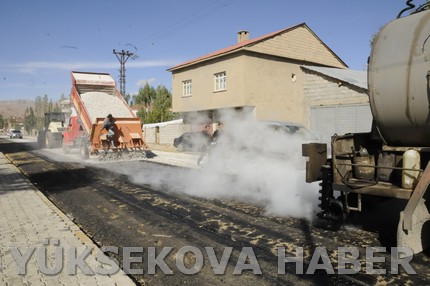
368;11;430;147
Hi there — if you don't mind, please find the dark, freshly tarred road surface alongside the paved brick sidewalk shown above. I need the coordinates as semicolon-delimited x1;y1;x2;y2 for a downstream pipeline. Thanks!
0;135;430;285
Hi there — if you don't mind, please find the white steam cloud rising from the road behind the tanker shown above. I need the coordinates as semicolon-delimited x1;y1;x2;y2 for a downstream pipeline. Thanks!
129;109;318;219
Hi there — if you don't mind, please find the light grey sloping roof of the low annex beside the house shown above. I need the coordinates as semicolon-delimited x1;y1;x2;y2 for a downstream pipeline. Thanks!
301;65;367;89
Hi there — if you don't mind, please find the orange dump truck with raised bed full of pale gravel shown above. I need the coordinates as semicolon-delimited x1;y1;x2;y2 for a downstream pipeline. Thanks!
62;71;147;160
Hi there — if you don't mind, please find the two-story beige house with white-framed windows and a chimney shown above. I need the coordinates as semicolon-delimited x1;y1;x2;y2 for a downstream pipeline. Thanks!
169;23;347;124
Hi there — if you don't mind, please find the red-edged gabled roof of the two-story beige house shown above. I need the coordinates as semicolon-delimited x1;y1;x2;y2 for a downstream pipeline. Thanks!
168;23;347;71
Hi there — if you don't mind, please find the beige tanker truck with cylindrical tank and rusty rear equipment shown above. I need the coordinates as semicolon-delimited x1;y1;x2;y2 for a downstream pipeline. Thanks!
302;1;430;253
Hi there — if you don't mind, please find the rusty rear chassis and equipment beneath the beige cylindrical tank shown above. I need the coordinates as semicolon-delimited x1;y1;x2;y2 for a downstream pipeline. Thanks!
302;132;430;253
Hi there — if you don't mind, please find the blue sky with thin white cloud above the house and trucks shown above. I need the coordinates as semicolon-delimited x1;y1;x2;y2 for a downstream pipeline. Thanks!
0;0;425;100
